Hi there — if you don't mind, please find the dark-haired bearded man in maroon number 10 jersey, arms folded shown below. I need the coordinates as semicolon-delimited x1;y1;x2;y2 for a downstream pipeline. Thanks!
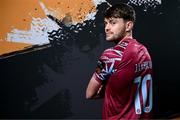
86;3;153;119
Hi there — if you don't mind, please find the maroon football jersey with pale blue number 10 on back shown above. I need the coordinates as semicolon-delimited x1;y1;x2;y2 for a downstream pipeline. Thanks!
94;38;153;119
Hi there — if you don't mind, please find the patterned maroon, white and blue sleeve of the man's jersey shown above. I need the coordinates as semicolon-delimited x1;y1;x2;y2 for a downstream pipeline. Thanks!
93;41;134;83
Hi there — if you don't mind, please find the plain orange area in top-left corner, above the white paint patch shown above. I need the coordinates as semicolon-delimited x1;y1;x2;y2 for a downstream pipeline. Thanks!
0;0;46;40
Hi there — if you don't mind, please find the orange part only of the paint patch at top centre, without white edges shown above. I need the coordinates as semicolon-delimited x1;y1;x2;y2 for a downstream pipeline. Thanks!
42;0;96;23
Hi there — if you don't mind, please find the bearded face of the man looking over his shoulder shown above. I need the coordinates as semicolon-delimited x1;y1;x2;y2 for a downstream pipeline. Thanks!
104;18;126;41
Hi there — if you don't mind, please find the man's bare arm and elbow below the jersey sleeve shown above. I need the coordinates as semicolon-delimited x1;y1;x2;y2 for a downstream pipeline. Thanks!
86;77;101;99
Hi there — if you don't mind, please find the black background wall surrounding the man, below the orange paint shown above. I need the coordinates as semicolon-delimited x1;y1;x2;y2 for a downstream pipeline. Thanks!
0;0;180;119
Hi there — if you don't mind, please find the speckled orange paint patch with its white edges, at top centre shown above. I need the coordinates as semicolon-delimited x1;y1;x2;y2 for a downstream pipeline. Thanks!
40;0;98;24
